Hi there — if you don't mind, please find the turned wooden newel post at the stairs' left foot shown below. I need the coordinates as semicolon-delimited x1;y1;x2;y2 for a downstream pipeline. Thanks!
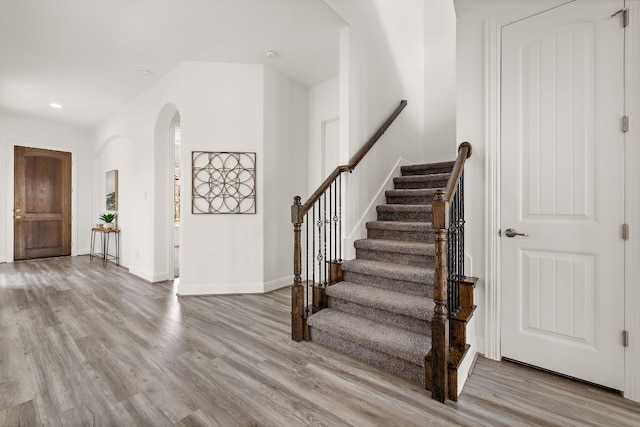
291;196;304;341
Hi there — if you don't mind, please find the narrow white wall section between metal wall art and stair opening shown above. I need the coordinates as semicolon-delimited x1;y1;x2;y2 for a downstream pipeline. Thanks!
260;67;309;291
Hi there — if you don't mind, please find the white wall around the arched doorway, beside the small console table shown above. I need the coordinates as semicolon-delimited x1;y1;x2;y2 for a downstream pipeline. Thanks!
92;63;183;281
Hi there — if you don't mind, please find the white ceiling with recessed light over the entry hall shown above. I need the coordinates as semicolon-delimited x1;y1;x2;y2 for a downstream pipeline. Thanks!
0;0;345;128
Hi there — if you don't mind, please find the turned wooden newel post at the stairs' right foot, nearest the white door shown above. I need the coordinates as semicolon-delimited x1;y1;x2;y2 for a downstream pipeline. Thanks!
431;190;449;402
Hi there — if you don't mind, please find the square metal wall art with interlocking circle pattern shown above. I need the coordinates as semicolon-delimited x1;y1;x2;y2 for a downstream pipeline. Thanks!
191;151;256;214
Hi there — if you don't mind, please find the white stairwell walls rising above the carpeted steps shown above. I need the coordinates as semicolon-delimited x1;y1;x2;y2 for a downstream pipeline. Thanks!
325;0;458;250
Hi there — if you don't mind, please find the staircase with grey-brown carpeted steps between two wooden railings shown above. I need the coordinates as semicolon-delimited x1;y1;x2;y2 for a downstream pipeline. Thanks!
307;162;475;400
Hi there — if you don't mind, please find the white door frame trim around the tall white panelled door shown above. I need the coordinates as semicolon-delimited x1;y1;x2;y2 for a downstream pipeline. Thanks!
484;0;640;401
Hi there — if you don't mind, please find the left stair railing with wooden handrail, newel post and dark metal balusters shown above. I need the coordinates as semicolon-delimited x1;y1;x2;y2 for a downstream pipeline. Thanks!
291;100;407;341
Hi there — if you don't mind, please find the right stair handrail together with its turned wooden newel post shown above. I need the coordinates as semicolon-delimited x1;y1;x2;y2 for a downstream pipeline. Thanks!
431;142;472;402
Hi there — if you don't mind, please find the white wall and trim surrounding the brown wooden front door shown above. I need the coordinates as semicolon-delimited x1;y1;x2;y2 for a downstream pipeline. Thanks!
0;112;95;262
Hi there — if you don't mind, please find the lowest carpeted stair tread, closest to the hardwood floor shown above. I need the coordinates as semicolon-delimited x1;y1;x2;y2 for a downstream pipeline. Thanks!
308;308;431;365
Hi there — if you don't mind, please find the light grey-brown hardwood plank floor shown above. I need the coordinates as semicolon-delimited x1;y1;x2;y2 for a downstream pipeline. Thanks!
0;257;640;426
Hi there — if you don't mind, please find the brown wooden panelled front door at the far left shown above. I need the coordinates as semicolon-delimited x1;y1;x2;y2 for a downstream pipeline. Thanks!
13;147;71;260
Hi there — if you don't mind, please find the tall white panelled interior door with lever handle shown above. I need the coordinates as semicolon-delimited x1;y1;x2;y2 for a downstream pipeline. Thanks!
500;0;624;390
